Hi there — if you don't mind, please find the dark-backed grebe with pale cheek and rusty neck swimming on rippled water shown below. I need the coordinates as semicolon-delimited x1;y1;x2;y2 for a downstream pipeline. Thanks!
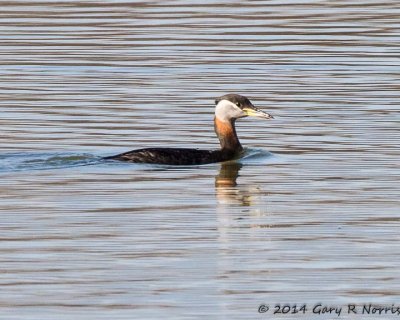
105;94;273;165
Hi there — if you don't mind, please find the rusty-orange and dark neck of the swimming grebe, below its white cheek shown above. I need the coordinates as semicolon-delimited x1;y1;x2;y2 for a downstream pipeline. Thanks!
214;117;243;153
